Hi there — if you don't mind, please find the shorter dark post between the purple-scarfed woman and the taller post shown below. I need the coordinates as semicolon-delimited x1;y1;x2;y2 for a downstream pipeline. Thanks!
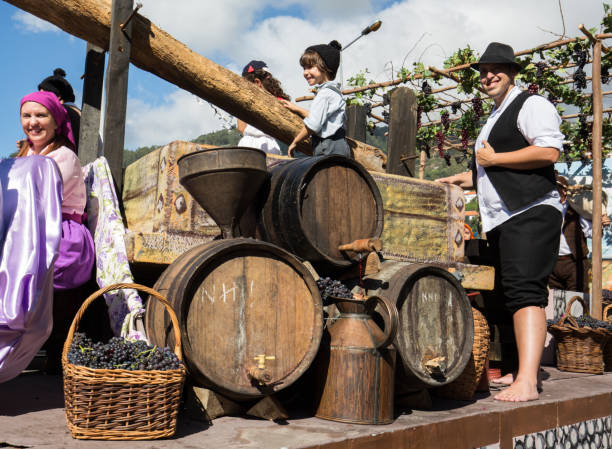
79;43;106;165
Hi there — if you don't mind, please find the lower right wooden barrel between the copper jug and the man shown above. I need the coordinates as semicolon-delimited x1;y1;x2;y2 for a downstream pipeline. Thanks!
364;261;474;389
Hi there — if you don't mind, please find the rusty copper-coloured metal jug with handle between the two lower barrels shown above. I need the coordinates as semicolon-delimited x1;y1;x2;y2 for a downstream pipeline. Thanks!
315;296;399;424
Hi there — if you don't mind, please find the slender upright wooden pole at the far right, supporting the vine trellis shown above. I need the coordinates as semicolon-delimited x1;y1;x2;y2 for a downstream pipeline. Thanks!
591;40;603;320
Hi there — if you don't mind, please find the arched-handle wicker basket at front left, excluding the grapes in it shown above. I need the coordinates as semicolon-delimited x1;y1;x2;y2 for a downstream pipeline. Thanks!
62;284;185;440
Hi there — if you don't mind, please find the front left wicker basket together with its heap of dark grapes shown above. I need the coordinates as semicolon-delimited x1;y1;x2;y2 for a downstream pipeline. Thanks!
62;284;185;440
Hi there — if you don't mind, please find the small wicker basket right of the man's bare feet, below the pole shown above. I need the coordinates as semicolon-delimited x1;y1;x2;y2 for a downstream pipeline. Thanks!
548;296;609;374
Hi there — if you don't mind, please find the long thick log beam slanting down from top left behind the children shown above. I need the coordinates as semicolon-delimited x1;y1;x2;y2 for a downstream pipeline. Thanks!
6;0;384;161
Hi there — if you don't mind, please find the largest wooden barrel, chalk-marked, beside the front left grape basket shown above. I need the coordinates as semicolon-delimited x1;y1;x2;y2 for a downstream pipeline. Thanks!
145;239;323;399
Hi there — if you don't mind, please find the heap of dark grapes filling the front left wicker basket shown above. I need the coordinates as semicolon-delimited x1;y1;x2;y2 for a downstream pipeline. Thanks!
68;332;181;371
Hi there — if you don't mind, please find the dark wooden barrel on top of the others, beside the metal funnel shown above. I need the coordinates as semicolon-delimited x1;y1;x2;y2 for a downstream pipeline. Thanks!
260;155;383;267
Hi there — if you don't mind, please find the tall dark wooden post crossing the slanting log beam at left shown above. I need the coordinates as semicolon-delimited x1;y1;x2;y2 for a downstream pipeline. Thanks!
102;0;134;192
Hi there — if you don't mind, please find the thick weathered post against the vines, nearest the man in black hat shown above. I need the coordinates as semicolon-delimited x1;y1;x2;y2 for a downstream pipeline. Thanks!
387;87;417;176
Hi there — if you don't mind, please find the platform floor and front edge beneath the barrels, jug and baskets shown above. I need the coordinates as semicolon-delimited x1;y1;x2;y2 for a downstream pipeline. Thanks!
0;368;612;449
